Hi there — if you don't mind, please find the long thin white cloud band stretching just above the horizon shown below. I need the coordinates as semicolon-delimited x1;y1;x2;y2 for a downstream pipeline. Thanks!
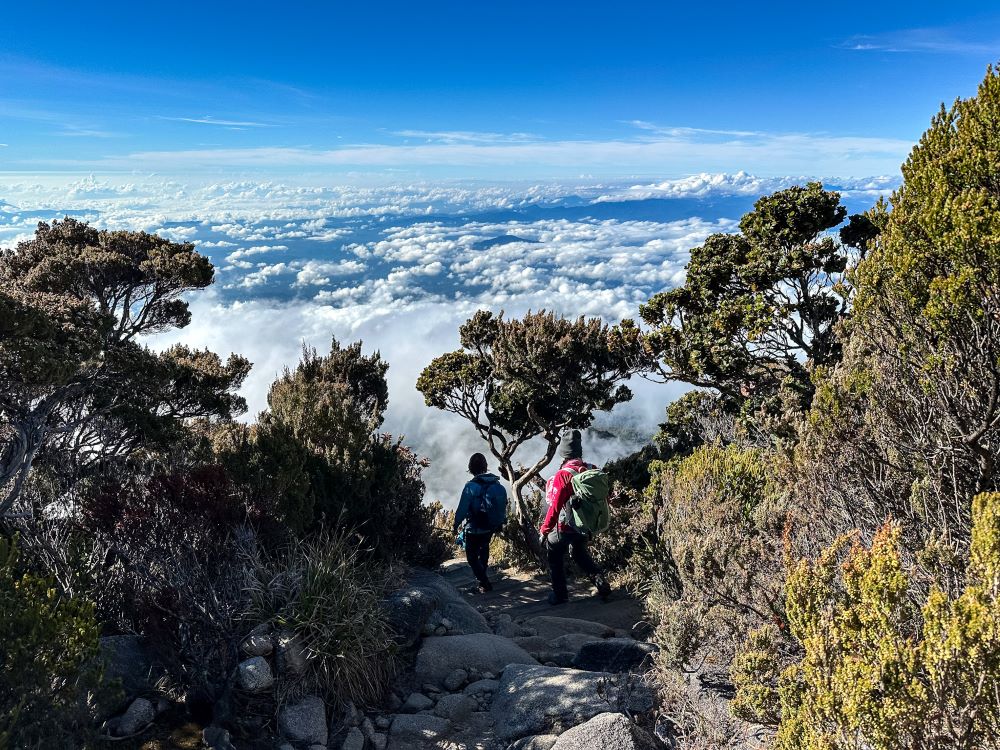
68;128;912;176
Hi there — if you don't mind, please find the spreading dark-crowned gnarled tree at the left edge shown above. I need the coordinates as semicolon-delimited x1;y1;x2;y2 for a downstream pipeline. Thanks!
0;219;250;517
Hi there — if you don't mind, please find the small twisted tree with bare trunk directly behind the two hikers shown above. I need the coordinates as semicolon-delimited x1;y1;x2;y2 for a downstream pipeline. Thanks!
417;310;648;548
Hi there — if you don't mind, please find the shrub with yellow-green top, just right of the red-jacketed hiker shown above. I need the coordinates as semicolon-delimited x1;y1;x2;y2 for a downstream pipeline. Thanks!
647;444;790;669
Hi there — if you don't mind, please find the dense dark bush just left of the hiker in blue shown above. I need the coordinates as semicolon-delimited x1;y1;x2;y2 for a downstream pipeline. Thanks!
256;340;443;564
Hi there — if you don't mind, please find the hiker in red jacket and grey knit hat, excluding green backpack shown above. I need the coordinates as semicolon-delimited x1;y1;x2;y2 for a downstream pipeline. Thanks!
539;430;611;604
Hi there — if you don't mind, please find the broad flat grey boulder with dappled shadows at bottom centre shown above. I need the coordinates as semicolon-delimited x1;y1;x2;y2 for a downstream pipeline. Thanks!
491;664;654;742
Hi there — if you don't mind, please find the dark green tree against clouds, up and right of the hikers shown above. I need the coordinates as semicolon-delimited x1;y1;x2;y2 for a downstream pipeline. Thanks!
641;182;847;408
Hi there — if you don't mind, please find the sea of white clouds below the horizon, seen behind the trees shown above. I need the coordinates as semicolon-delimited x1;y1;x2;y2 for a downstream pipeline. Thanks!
0;172;896;505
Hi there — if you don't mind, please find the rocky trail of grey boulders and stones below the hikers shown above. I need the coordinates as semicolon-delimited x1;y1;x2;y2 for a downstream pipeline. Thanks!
97;561;671;750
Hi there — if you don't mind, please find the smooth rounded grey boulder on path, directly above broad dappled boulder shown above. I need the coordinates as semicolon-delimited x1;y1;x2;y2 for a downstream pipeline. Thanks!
415;633;538;685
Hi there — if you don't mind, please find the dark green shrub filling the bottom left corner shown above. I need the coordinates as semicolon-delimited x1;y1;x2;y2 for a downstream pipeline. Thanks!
0;536;105;750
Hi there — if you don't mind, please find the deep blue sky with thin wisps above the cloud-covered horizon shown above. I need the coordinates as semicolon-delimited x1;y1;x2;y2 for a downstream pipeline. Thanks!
0;0;1000;180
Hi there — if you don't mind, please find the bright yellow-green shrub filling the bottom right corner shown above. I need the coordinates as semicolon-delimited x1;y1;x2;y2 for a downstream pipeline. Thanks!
735;493;1000;750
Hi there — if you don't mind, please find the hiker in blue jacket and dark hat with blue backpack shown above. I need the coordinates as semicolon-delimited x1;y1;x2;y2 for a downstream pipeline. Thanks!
454;453;507;594
